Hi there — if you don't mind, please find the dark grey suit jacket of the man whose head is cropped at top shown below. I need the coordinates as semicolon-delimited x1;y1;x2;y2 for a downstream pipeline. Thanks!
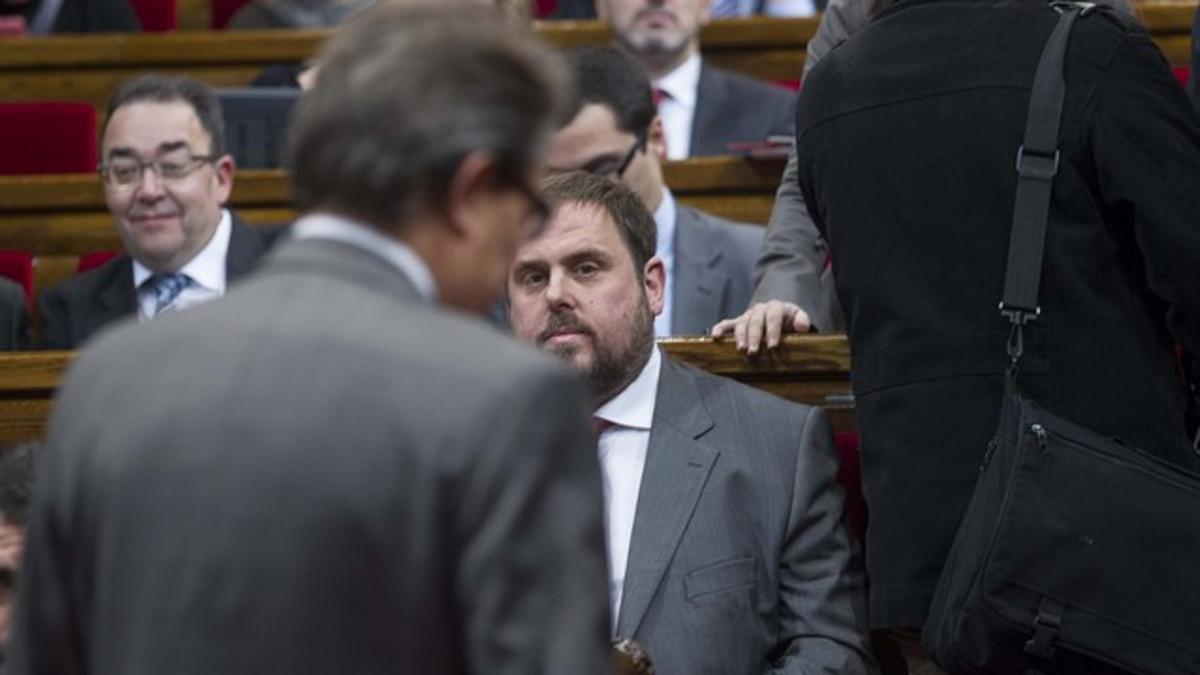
690;62;796;156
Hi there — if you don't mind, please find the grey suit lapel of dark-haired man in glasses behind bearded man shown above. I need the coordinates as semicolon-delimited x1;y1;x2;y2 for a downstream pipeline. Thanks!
671;205;730;333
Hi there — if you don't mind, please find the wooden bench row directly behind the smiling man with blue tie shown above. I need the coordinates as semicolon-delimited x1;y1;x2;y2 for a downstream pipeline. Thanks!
0;157;784;297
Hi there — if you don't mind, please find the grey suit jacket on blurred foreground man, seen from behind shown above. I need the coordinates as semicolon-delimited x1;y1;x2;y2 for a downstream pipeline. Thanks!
10;234;610;675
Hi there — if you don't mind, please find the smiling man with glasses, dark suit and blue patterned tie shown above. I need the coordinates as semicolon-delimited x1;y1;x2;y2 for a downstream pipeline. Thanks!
40;74;280;350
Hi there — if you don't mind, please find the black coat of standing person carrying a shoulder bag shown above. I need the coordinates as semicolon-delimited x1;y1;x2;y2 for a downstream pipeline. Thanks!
797;0;1200;627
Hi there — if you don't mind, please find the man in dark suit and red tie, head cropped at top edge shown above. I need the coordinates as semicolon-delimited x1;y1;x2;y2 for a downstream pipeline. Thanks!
596;0;796;160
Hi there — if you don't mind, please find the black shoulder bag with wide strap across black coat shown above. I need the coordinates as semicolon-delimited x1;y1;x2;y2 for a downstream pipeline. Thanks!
923;2;1200;675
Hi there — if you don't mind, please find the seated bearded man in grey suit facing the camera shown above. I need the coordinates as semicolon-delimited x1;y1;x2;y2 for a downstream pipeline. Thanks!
509;172;875;675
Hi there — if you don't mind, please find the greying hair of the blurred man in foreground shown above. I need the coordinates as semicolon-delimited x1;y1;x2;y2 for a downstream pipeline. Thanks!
288;0;571;229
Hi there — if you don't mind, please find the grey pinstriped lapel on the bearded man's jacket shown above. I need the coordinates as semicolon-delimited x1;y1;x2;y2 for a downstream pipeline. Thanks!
617;358;720;638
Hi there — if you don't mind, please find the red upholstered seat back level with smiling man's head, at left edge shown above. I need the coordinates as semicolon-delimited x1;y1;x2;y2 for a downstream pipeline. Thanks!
0;101;97;175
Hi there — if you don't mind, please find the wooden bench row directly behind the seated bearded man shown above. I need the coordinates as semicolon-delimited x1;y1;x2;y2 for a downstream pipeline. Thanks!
0;335;854;444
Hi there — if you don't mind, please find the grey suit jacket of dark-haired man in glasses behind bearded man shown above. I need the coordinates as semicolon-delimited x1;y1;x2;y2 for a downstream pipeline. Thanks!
671;202;763;335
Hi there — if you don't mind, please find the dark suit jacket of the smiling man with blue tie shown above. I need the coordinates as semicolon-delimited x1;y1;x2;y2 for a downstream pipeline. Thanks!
38;211;280;350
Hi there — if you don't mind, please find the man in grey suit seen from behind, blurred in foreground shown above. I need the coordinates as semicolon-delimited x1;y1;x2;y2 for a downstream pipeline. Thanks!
12;0;611;675
